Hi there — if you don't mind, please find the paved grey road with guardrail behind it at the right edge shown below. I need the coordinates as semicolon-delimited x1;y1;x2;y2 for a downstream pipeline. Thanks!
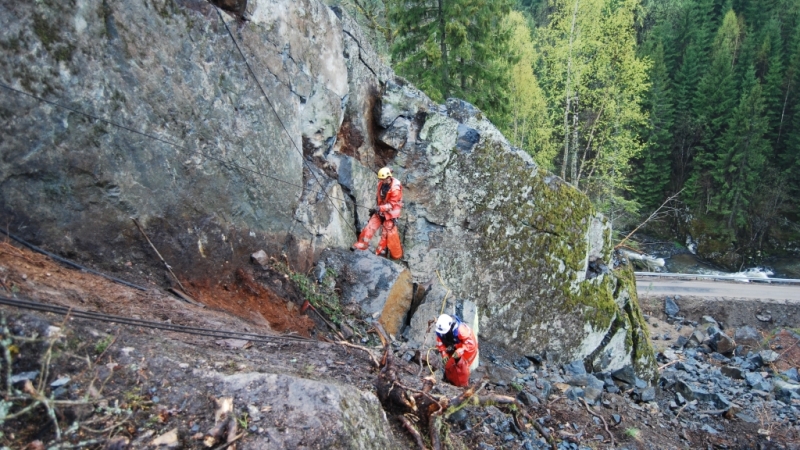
636;277;800;303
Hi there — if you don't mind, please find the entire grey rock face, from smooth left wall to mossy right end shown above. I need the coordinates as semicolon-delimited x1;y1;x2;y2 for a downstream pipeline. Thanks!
0;0;656;379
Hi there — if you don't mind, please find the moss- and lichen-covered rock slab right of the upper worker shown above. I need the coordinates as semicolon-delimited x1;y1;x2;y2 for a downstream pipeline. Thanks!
372;91;655;379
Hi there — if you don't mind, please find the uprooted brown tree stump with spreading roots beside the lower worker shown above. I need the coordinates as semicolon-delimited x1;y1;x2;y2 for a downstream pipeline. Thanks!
374;323;556;450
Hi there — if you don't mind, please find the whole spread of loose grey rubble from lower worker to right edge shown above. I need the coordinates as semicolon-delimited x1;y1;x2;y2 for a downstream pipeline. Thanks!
432;299;800;449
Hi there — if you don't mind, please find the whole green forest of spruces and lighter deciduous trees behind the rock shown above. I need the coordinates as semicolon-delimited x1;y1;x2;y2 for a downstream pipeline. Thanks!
337;0;800;268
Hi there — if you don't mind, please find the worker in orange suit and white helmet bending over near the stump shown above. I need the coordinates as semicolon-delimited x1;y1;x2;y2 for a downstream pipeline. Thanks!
436;314;478;387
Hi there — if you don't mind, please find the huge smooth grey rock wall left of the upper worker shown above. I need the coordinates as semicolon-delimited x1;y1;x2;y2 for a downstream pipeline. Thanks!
0;0;355;279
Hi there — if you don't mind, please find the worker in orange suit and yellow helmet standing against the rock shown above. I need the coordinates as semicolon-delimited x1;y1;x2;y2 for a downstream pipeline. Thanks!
353;167;403;259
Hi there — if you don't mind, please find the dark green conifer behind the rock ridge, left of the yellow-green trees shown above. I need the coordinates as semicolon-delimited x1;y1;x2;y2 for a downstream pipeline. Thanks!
387;0;514;122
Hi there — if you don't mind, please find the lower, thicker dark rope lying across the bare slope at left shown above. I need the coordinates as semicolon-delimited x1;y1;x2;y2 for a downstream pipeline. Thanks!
0;296;318;343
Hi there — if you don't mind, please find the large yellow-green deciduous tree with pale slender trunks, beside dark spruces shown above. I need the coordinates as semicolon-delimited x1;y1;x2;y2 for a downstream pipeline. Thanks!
536;0;650;221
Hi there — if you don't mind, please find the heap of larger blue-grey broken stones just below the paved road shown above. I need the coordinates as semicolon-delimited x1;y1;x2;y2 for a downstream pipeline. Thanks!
658;297;800;434
